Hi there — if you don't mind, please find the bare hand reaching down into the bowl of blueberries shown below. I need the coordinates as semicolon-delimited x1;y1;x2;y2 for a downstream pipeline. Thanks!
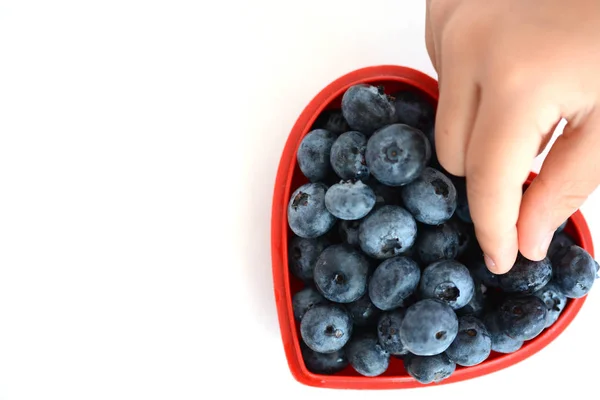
426;0;600;273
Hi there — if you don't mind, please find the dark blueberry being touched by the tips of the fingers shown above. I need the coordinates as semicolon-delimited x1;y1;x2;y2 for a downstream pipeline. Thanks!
498;254;552;294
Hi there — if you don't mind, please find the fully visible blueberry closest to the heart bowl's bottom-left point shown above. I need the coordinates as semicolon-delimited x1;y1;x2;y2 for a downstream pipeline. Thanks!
300;303;352;353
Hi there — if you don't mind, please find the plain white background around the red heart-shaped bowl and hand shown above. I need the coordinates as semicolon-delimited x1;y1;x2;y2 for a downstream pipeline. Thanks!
0;0;600;400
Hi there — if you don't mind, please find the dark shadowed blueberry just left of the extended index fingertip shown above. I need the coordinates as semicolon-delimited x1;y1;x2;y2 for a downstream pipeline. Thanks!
415;223;458;264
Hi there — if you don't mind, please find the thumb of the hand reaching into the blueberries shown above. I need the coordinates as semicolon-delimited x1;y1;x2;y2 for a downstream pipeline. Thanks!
517;110;600;260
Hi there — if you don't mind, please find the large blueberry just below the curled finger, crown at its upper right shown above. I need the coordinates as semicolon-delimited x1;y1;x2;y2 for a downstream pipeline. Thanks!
400;167;456;225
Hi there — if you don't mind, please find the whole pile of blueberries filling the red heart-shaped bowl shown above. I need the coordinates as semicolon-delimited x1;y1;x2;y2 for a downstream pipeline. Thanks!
287;84;598;384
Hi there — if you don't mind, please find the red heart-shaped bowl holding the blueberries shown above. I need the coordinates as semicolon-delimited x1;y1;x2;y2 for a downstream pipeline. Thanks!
271;65;594;389
